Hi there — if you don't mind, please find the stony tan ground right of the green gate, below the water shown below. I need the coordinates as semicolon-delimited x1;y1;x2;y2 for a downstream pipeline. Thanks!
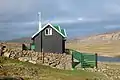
98;62;120;80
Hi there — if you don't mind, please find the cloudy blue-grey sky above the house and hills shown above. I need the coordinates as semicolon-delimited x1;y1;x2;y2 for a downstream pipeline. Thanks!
0;0;120;40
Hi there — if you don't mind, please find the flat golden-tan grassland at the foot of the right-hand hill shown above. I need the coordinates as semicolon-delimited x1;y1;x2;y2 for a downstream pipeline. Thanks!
66;40;120;57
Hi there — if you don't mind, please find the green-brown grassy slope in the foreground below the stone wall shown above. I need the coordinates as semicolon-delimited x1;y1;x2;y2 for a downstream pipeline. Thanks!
0;57;105;80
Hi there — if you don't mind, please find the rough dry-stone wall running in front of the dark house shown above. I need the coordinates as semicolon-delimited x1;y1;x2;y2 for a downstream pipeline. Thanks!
2;45;72;70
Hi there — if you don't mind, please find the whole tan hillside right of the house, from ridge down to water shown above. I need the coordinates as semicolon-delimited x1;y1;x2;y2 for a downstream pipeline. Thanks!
66;31;120;57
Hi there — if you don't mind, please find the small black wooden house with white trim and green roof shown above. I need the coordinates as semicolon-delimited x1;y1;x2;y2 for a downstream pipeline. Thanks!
32;23;67;53
